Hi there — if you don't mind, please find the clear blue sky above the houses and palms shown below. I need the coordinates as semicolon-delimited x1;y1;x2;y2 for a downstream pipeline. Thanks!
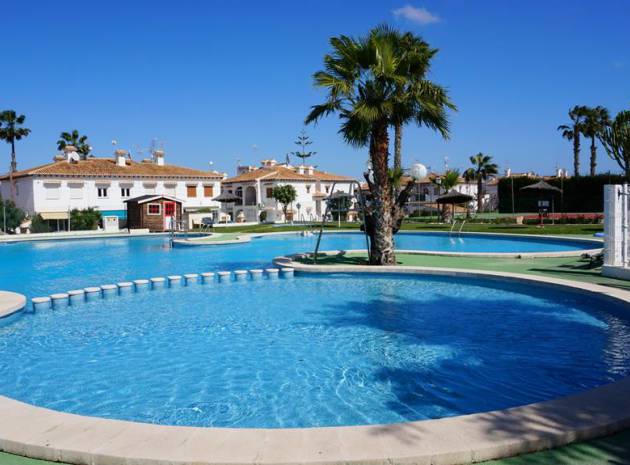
0;0;630;176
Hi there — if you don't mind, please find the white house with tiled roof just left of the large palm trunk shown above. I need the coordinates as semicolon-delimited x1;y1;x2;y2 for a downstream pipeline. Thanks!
221;160;354;222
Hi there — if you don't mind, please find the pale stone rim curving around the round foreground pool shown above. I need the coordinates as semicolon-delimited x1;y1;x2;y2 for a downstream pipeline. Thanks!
0;268;630;465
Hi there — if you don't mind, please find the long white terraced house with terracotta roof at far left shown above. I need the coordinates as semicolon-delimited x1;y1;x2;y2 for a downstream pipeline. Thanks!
0;146;224;229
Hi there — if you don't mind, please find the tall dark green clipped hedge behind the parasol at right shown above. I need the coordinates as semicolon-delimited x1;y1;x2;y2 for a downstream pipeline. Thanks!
499;173;625;213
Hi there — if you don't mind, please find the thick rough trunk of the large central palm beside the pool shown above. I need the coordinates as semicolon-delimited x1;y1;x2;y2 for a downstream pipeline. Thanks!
370;121;396;265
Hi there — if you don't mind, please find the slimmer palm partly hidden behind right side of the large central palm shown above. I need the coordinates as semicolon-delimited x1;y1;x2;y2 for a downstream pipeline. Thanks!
380;26;457;170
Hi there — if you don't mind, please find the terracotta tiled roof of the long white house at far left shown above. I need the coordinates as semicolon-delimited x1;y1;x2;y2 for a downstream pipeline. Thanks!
0;158;222;180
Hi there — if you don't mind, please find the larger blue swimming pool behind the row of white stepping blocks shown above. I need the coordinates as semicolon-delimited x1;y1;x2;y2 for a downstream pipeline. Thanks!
0;233;601;297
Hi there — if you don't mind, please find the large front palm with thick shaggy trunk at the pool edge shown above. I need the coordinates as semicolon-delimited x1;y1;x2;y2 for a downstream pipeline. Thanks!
306;27;448;265
